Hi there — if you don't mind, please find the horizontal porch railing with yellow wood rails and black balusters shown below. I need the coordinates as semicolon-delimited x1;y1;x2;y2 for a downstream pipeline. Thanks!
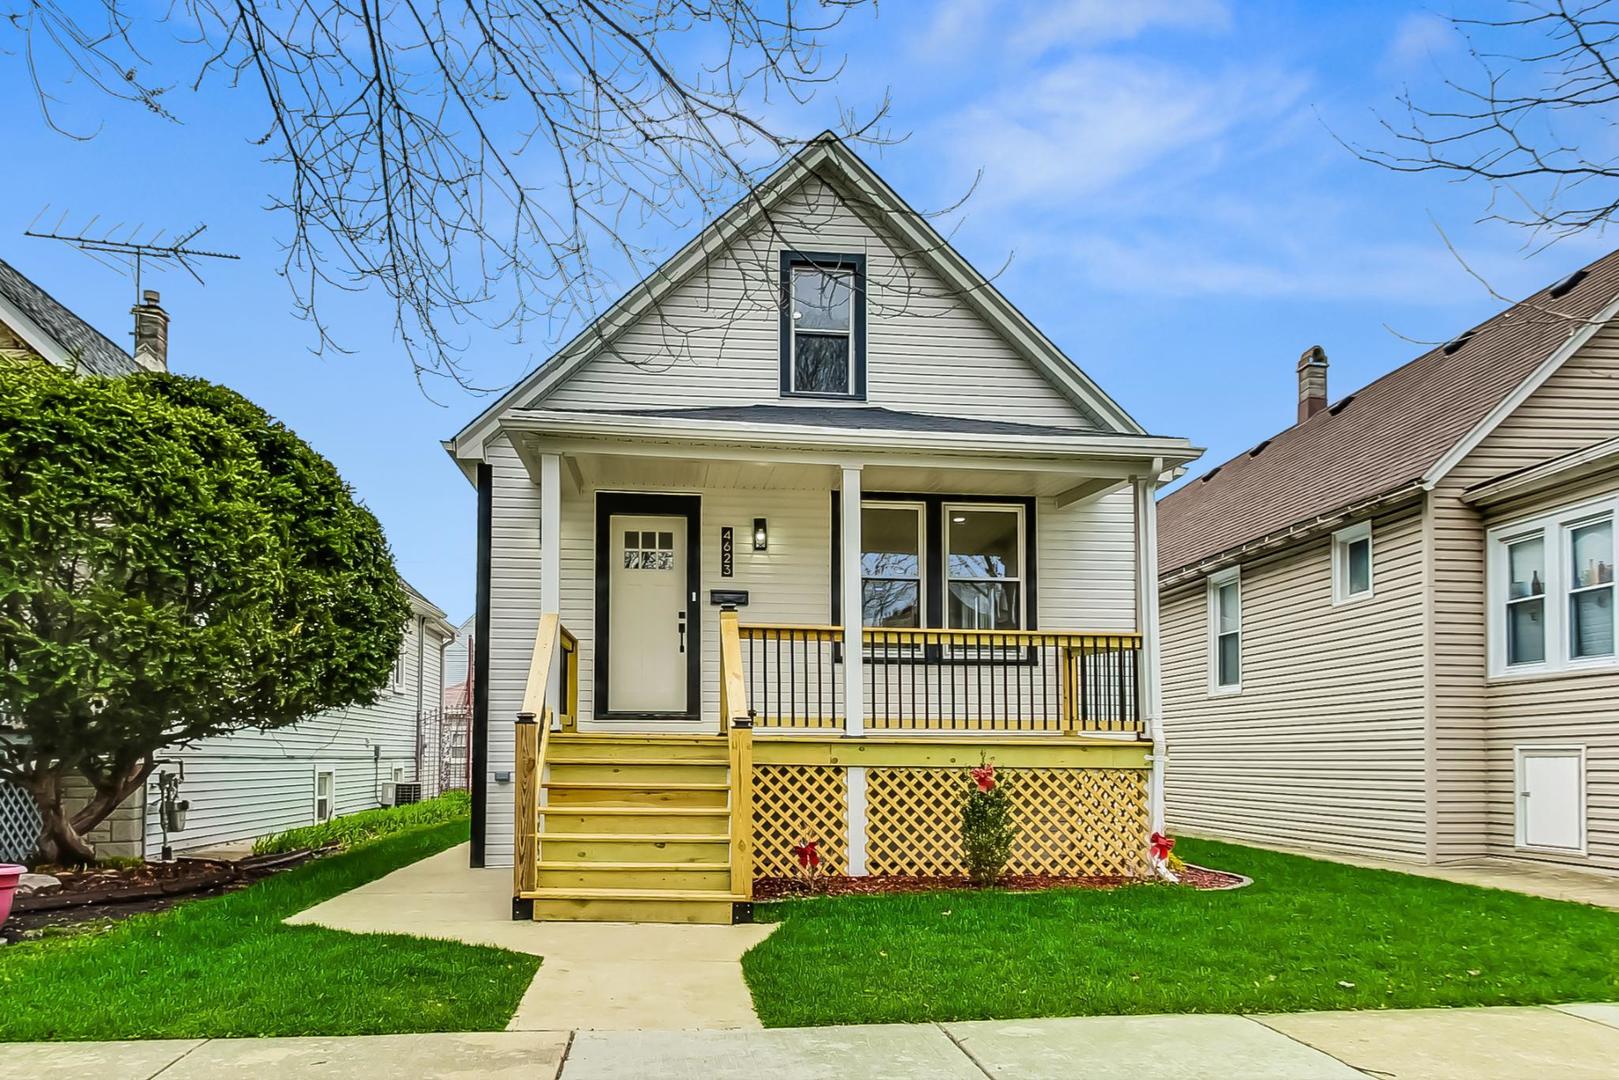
740;625;1143;735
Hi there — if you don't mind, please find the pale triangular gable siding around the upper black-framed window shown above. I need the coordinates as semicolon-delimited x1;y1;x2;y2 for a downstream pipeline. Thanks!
544;180;1098;427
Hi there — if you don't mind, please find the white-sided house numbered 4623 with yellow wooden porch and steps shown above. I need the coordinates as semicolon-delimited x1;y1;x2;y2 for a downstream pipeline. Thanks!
447;136;1198;921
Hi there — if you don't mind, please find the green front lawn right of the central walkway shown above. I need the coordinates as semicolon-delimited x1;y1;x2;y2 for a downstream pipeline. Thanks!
743;840;1619;1027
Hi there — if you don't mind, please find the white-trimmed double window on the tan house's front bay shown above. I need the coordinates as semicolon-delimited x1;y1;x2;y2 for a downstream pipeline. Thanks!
1488;500;1619;675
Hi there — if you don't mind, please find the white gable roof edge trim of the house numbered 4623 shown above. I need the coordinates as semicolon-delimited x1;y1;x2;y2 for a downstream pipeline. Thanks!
447;131;1146;453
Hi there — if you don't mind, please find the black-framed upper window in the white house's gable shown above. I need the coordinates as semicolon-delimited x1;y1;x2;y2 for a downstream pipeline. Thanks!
782;251;866;400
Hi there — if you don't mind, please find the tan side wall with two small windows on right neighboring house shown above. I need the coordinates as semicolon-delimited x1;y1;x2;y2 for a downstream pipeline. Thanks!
1162;505;1426;860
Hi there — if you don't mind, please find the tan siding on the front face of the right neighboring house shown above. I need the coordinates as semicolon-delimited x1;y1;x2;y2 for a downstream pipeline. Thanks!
1433;318;1619;860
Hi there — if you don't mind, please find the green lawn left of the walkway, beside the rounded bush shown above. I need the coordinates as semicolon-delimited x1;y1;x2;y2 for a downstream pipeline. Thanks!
0;821;539;1041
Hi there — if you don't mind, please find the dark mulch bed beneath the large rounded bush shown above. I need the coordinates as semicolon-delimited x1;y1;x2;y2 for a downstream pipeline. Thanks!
0;850;317;941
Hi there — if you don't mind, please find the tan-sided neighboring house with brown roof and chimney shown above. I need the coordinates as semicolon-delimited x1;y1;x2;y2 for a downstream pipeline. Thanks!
1158;253;1619;870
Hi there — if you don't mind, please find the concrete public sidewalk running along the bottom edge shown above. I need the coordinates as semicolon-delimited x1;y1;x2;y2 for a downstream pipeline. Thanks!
19;1006;1619;1080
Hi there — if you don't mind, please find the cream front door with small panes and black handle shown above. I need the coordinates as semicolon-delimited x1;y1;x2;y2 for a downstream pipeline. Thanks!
607;513;691;714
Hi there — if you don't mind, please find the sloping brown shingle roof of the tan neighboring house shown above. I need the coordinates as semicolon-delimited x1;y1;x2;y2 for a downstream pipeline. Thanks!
1158;251;1619;575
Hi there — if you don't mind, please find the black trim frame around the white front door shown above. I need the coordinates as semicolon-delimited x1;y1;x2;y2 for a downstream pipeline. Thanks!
594;491;703;721
